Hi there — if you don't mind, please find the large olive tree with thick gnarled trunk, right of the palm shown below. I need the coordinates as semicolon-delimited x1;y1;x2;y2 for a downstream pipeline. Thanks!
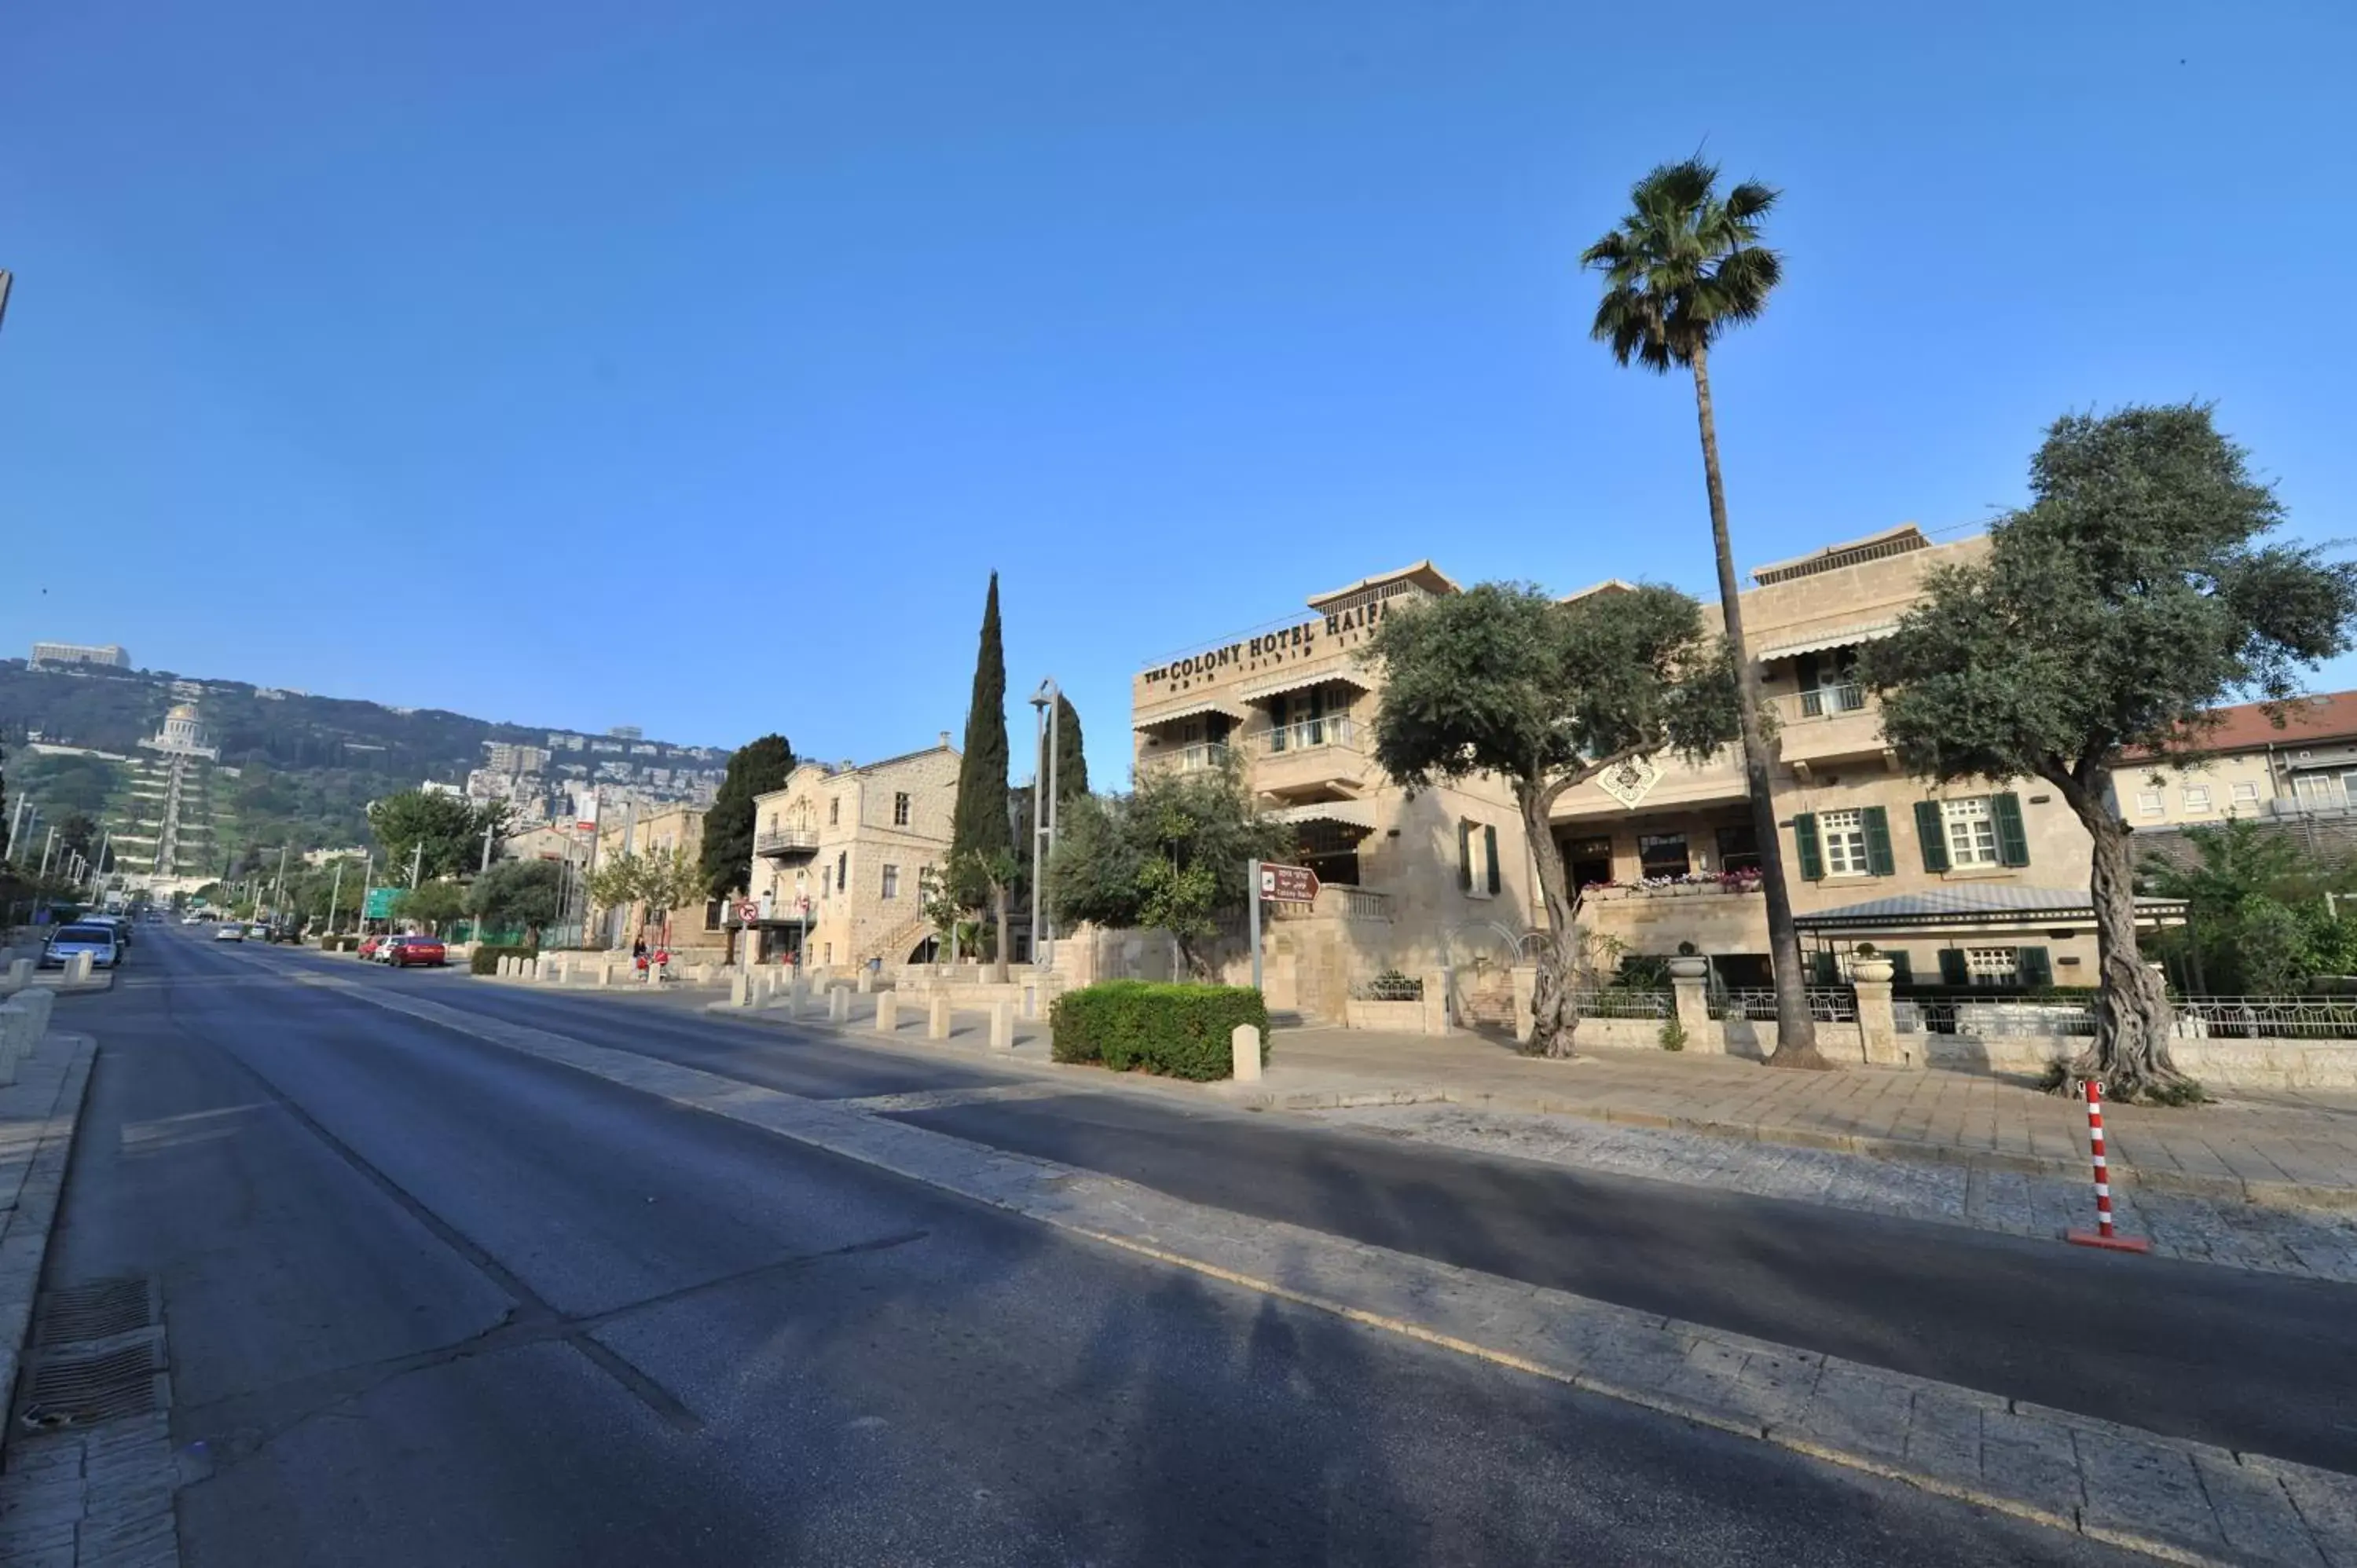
1860;403;2357;1101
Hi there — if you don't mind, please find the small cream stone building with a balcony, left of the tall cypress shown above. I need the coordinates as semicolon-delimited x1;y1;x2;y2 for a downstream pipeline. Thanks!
745;731;959;969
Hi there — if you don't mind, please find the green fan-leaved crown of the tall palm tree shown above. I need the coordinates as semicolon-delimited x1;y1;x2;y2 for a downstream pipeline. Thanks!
1579;158;1784;372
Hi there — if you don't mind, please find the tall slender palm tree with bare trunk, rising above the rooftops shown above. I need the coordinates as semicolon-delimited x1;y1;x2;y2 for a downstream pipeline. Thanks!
1579;158;1827;1068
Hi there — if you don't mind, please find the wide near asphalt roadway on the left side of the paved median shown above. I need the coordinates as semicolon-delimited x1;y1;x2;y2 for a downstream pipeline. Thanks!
49;932;2159;1568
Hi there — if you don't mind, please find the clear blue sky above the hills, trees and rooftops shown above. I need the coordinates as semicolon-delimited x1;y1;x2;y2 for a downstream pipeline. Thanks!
0;0;2357;780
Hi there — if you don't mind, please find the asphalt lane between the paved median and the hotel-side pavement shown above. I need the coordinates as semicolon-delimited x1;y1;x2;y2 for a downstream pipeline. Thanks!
306;933;2357;1471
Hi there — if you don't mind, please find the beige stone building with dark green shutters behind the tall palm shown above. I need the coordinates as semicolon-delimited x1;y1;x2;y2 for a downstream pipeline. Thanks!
1553;523;2159;988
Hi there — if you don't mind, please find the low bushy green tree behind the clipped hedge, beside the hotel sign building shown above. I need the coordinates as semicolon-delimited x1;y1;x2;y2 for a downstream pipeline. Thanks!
1047;759;1294;972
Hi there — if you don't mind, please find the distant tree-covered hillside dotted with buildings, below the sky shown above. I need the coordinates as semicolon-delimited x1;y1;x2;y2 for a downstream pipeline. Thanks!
0;658;726;859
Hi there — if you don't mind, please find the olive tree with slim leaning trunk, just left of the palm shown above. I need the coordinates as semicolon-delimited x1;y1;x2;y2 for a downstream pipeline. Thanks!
1369;582;1739;1057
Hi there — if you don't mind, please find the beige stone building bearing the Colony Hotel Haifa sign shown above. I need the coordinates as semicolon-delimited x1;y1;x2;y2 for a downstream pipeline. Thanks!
1127;561;1534;1017
